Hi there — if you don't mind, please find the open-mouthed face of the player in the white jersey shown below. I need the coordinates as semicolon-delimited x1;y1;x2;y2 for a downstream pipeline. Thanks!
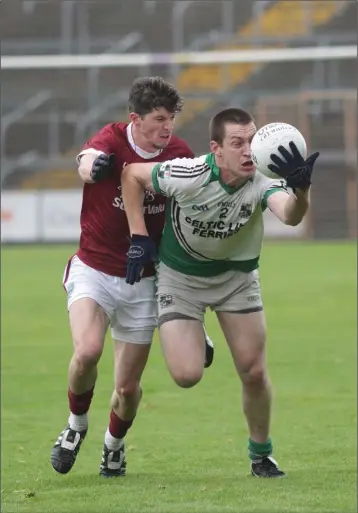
214;122;256;178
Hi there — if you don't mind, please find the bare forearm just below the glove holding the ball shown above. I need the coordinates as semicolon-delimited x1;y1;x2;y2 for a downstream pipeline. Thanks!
267;189;309;226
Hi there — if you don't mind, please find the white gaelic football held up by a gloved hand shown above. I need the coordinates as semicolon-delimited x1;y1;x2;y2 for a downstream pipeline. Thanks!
251;123;307;178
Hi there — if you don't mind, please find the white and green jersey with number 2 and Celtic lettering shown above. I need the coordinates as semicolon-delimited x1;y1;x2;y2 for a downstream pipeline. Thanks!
152;153;288;276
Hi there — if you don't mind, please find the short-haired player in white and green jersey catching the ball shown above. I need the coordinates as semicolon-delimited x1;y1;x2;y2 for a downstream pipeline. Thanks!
122;109;318;477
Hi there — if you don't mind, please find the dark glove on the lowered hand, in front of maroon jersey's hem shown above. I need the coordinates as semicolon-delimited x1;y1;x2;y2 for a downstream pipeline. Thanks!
126;235;157;285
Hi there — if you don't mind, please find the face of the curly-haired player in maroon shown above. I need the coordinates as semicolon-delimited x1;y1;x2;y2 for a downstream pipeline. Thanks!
132;107;175;151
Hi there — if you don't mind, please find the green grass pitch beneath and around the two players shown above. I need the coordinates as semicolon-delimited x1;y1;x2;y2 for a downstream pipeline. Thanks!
1;243;357;513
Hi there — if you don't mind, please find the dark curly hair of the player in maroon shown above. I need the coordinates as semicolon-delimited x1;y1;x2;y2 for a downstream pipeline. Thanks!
128;77;183;116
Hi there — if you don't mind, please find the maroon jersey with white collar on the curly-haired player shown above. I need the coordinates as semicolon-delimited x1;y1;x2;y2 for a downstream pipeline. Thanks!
77;123;194;277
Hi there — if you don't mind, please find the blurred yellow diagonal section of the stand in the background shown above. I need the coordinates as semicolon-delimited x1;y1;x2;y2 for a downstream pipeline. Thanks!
178;0;347;134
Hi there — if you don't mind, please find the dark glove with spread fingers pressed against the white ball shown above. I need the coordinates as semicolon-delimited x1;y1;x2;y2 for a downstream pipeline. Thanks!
267;141;319;190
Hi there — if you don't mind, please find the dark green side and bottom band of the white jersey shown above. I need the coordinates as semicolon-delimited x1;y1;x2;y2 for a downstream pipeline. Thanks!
159;198;260;276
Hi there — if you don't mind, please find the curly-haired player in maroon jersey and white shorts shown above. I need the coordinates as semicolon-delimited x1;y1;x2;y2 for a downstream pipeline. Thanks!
51;77;213;477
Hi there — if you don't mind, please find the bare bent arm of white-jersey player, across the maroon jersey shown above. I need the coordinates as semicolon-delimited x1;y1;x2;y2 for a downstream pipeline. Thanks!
122;162;156;235
